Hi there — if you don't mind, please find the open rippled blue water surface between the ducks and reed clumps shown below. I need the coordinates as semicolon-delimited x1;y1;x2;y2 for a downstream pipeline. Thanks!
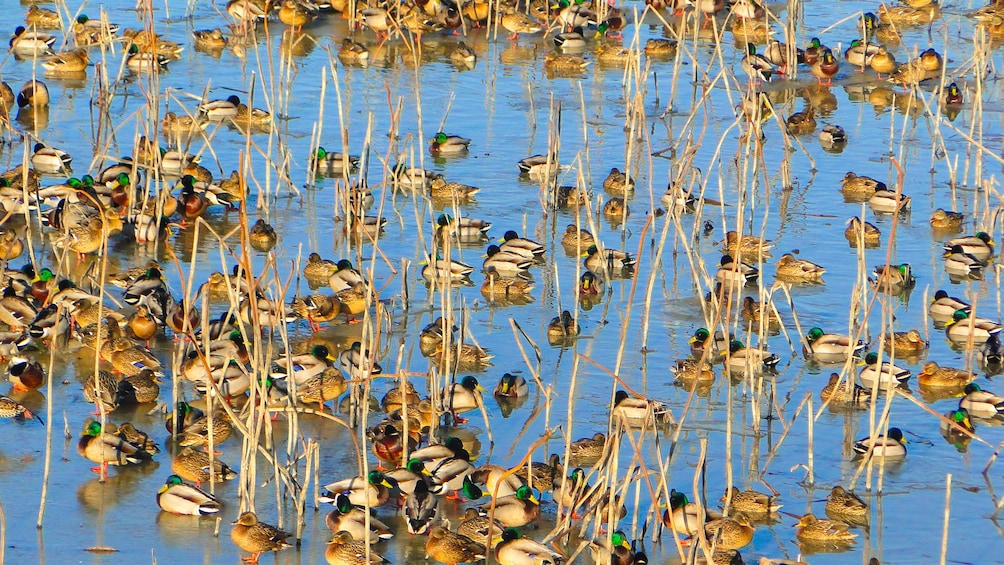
0;2;1004;564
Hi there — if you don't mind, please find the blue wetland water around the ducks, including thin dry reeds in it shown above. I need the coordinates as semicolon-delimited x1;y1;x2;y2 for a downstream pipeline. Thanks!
0;1;1004;564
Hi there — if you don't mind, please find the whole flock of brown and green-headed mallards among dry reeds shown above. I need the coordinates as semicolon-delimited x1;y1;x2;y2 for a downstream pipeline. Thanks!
0;0;1004;565
